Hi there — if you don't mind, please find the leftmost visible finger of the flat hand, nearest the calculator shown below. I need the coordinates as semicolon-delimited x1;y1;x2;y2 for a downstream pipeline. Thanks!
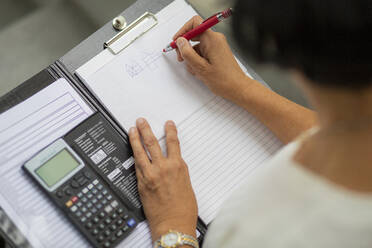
129;127;150;175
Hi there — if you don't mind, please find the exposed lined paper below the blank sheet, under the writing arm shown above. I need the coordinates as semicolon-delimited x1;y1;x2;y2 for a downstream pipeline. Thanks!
176;97;282;224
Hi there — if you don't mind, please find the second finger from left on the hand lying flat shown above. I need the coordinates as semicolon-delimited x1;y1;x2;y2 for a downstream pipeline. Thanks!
136;118;163;162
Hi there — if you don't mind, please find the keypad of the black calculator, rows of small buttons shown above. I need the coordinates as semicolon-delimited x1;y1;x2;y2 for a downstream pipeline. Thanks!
65;175;136;247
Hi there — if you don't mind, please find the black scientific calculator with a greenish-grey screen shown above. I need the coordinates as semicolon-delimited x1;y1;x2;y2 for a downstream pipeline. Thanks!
23;139;138;247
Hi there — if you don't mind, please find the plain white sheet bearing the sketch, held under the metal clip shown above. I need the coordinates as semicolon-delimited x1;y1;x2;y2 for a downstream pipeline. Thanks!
78;1;218;140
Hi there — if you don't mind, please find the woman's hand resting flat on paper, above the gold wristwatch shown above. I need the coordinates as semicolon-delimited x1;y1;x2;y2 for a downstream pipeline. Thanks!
129;118;198;241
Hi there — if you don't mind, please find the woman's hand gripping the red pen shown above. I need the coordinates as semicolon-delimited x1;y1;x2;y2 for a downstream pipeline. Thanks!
173;16;248;102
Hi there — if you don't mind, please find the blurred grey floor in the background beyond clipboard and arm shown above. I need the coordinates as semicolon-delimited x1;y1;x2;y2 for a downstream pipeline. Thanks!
0;0;306;108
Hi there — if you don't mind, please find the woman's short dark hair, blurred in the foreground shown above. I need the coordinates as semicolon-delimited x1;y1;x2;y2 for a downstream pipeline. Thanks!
233;0;372;89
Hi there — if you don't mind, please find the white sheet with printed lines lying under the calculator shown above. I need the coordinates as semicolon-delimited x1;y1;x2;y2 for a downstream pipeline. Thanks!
0;79;93;247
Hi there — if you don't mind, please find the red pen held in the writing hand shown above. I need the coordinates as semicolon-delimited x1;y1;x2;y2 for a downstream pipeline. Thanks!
163;8;232;52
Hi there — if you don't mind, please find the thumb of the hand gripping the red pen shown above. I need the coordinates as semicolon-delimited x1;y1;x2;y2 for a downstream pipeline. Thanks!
176;37;208;71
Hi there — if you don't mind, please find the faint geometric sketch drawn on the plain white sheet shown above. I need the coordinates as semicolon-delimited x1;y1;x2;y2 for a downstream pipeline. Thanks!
124;50;163;78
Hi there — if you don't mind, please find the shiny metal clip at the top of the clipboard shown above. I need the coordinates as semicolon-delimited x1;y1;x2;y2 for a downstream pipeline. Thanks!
104;12;158;55
